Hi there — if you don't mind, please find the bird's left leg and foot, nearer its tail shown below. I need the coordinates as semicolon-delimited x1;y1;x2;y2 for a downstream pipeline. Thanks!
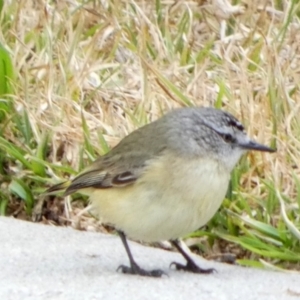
117;230;165;277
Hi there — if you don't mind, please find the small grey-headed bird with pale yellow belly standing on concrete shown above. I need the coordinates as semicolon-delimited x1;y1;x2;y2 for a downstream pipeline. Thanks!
47;107;275;277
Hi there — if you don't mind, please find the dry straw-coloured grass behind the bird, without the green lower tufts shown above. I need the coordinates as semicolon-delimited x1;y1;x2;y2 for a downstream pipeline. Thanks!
0;0;300;270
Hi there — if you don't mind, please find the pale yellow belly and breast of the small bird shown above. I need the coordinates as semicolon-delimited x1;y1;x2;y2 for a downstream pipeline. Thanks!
90;158;230;242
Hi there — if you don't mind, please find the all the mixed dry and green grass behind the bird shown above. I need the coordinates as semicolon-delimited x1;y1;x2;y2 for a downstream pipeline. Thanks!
0;0;300;269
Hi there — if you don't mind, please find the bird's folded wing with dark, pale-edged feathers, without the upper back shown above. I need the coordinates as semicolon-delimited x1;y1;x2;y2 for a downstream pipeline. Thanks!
64;153;149;196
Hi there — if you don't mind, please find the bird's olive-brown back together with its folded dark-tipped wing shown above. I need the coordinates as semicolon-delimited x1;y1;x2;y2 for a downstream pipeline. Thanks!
65;118;169;195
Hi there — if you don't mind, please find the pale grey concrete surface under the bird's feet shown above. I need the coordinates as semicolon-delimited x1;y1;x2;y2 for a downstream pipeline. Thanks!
0;217;300;300
